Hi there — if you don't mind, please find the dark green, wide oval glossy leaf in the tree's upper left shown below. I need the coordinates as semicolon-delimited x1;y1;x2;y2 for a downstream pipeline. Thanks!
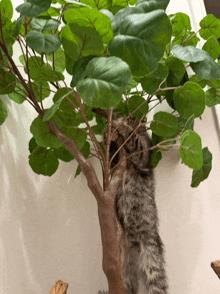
26;31;61;53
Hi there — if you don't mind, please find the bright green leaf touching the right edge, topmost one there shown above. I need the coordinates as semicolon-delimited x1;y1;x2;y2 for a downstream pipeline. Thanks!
199;14;220;40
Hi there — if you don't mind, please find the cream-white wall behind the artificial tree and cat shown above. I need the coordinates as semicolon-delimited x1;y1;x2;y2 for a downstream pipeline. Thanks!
0;0;220;294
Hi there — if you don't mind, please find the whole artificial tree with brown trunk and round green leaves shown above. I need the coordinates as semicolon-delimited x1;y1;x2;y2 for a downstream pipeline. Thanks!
0;0;220;294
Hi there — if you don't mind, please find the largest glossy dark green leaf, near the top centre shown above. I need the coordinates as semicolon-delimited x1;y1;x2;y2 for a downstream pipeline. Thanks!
108;10;172;77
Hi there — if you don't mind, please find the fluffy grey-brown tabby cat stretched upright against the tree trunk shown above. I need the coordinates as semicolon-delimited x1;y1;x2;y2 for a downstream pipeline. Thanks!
104;117;168;294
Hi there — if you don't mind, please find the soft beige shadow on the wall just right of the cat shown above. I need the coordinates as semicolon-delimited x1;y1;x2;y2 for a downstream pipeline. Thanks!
155;150;202;294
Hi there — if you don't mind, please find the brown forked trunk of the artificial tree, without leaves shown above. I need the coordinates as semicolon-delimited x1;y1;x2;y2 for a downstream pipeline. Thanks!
47;121;126;294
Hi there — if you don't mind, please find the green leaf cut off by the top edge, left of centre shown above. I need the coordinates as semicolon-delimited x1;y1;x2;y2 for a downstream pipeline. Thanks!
16;0;52;17
